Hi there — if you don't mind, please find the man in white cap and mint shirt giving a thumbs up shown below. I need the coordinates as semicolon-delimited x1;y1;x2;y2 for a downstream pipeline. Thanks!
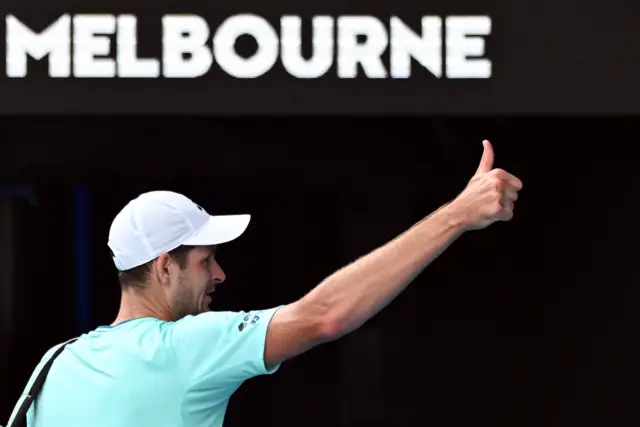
7;141;522;427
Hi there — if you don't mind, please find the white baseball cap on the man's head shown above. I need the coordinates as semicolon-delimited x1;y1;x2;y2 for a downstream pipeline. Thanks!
108;191;251;271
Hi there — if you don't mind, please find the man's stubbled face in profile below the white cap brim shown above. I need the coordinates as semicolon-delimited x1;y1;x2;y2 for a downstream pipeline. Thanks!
171;247;225;319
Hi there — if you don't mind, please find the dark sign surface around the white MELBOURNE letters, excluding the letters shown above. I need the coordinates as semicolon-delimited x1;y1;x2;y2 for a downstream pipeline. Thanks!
0;0;640;116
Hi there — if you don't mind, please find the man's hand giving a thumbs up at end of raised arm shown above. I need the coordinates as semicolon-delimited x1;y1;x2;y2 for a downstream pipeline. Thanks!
451;140;522;230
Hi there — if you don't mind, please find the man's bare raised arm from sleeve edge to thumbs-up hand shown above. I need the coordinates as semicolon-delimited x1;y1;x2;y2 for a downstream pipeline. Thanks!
265;141;522;367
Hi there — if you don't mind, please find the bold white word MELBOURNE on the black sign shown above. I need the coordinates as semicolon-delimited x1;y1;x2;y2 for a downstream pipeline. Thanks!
6;14;492;79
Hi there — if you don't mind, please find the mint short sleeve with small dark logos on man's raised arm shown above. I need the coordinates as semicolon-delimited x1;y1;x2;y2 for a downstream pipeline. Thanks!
171;307;280;388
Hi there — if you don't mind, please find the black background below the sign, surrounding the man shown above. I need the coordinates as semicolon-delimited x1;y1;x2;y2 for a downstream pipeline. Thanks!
0;117;640;427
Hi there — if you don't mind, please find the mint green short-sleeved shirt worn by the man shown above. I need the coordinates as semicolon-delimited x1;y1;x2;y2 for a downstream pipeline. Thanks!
16;308;278;427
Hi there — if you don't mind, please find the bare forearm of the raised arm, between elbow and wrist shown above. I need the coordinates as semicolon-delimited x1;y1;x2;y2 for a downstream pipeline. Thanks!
300;205;464;340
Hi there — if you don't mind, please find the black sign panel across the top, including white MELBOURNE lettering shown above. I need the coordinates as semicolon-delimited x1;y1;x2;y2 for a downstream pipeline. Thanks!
0;0;640;115
